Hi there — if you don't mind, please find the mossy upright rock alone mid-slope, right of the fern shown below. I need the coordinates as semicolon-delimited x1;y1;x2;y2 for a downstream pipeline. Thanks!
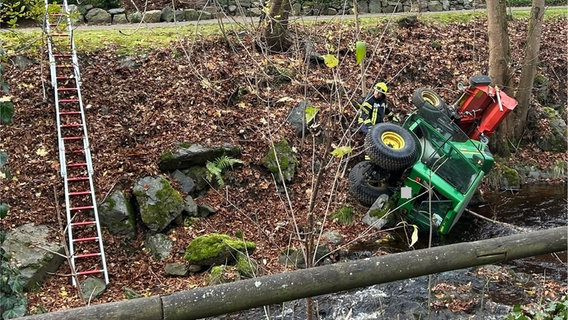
262;139;298;183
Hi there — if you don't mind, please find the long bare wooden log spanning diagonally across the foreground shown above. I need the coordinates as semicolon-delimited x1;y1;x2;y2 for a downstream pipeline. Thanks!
24;227;568;320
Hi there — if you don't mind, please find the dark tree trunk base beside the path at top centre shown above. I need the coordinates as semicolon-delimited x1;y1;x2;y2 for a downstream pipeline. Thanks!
262;0;292;52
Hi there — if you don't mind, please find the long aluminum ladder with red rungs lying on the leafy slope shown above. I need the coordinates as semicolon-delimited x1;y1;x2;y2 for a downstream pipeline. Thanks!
44;0;109;286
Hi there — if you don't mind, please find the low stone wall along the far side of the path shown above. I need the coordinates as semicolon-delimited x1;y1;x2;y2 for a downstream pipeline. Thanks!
69;0;485;24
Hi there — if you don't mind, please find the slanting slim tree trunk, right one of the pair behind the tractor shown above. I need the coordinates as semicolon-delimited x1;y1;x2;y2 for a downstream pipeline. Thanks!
513;0;544;141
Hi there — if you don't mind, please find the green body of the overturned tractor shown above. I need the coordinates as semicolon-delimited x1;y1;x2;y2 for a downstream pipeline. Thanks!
400;110;493;234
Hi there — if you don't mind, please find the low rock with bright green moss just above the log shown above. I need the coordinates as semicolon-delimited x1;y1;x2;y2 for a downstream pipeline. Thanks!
184;233;256;266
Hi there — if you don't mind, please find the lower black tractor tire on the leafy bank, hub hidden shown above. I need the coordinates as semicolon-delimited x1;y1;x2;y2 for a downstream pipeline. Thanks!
349;161;392;207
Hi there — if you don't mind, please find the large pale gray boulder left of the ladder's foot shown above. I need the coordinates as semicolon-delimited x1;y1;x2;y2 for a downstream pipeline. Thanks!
2;224;65;290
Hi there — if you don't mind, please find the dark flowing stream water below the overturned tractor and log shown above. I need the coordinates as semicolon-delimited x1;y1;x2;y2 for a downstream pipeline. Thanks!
211;184;568;320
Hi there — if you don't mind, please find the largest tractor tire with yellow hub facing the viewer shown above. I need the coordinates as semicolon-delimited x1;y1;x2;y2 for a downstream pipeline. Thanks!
365;123;417;171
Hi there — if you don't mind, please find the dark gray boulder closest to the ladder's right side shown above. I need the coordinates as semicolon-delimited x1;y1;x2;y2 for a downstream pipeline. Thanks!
98;191;136;238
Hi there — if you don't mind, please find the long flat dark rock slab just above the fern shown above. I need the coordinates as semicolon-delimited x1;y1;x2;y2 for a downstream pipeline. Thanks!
158;144;241;171
